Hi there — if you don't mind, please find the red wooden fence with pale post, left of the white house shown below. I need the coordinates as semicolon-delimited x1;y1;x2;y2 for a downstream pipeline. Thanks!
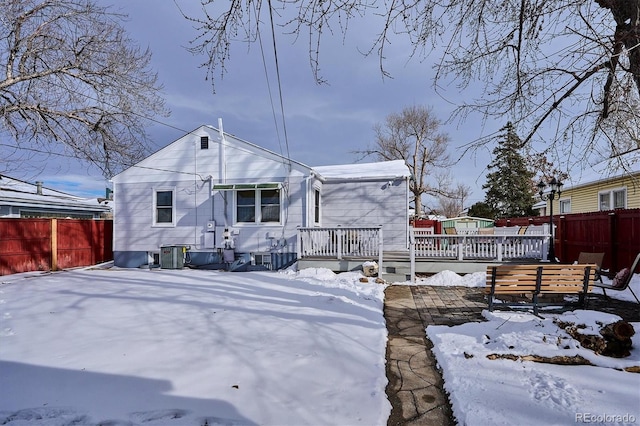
0;219;113;275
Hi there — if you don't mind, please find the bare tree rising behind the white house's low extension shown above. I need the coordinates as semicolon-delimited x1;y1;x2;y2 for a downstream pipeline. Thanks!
356;106;451;217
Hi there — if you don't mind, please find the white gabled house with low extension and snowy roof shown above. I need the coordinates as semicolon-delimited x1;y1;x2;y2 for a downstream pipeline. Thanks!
112;125;410;267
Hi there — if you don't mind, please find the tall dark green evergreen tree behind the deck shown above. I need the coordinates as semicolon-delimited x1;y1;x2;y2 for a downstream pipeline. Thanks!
482;122;537;218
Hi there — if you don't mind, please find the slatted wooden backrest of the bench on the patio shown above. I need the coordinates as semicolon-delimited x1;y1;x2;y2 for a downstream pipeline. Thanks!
485;264;596;294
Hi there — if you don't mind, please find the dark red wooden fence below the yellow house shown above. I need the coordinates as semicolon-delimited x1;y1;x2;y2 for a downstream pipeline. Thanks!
495;209;640;272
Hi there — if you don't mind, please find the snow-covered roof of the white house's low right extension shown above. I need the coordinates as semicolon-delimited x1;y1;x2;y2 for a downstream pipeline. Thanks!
313;160;411;180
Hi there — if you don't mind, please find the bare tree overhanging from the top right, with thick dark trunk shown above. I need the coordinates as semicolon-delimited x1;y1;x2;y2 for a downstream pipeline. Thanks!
191;0;640;170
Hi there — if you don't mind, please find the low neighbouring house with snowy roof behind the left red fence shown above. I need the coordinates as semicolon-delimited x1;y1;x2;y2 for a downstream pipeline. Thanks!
0;175;111;219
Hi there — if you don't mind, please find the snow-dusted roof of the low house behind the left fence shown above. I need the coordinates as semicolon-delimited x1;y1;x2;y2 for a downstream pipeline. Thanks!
0;175;111;212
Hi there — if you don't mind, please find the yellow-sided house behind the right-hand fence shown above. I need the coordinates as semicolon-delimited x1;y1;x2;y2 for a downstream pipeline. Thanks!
536;163;640;216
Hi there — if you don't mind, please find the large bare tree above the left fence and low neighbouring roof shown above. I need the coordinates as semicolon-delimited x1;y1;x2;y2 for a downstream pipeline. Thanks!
0;0;167;176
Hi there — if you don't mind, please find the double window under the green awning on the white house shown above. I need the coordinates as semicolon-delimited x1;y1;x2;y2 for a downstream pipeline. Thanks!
236;189;280;223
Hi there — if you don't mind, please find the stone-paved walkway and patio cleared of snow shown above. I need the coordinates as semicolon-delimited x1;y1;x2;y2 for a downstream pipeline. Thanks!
384;285;640;426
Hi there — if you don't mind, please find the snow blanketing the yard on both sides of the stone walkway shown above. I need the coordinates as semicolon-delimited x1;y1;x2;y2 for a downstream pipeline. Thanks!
0;268;640;426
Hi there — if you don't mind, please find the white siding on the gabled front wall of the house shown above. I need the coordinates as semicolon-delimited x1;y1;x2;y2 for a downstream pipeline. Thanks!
113;127;316;260
